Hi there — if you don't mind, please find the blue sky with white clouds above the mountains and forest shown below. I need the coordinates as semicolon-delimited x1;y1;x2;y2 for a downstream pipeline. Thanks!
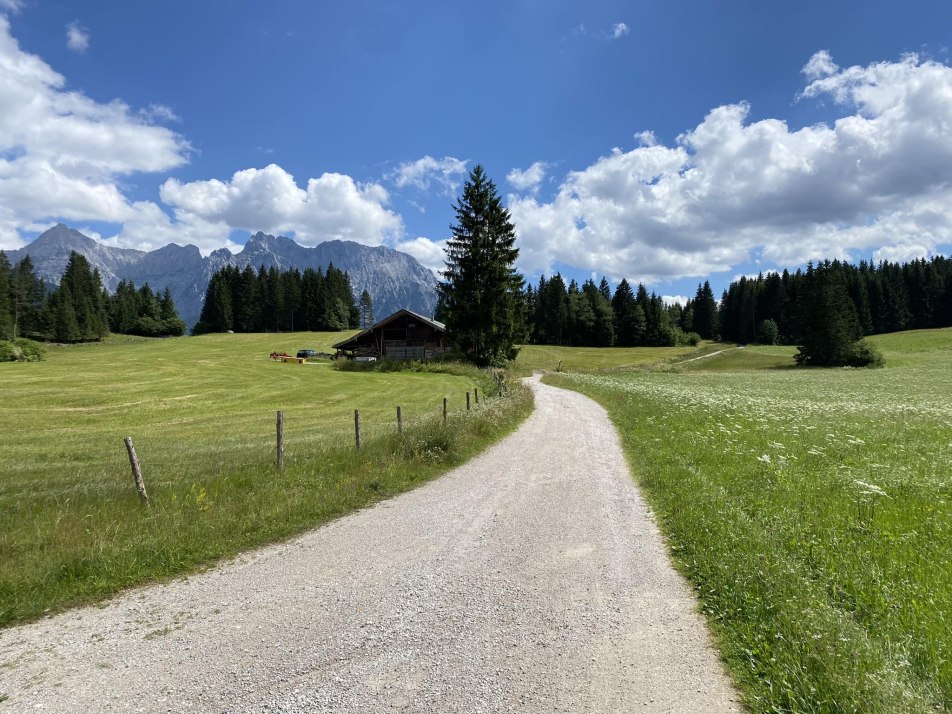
0;0;952;296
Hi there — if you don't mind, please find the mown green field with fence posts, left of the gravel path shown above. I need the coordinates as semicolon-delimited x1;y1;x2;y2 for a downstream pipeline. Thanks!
0;333;531;625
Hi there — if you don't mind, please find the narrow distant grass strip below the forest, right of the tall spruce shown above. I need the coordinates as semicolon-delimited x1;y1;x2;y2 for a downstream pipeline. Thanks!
515;345;701;374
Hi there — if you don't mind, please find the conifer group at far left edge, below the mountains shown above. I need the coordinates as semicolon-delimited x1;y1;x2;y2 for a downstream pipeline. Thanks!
0;251;185;342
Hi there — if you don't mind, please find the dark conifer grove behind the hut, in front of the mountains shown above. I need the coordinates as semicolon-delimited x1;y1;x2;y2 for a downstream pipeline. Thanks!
192;264;362;335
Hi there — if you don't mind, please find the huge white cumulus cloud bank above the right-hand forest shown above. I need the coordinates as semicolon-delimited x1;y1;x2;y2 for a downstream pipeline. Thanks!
509;52;952;282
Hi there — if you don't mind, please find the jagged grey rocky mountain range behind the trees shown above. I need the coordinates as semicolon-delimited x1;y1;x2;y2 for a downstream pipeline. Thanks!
7;223;436;326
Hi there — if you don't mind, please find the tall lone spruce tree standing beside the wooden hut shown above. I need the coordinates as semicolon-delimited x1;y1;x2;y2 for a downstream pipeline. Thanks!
438;165;523;364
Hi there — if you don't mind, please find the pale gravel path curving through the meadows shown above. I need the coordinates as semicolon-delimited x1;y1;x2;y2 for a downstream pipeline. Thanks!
0;380;740;714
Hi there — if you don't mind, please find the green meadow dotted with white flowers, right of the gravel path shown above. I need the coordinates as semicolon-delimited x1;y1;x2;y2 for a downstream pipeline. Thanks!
547;330;952;712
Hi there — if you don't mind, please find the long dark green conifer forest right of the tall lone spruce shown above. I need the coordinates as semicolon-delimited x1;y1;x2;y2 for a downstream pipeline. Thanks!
523;256;952;366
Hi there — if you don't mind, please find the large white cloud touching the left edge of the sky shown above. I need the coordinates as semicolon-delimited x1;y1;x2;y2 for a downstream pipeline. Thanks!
0;13;190;248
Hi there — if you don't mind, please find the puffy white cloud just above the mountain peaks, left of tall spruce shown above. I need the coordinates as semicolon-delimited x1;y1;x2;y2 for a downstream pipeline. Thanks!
159;164;403;245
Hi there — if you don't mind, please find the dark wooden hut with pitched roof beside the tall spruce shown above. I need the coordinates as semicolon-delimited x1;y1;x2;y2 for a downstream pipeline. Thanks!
334;310;448;360
